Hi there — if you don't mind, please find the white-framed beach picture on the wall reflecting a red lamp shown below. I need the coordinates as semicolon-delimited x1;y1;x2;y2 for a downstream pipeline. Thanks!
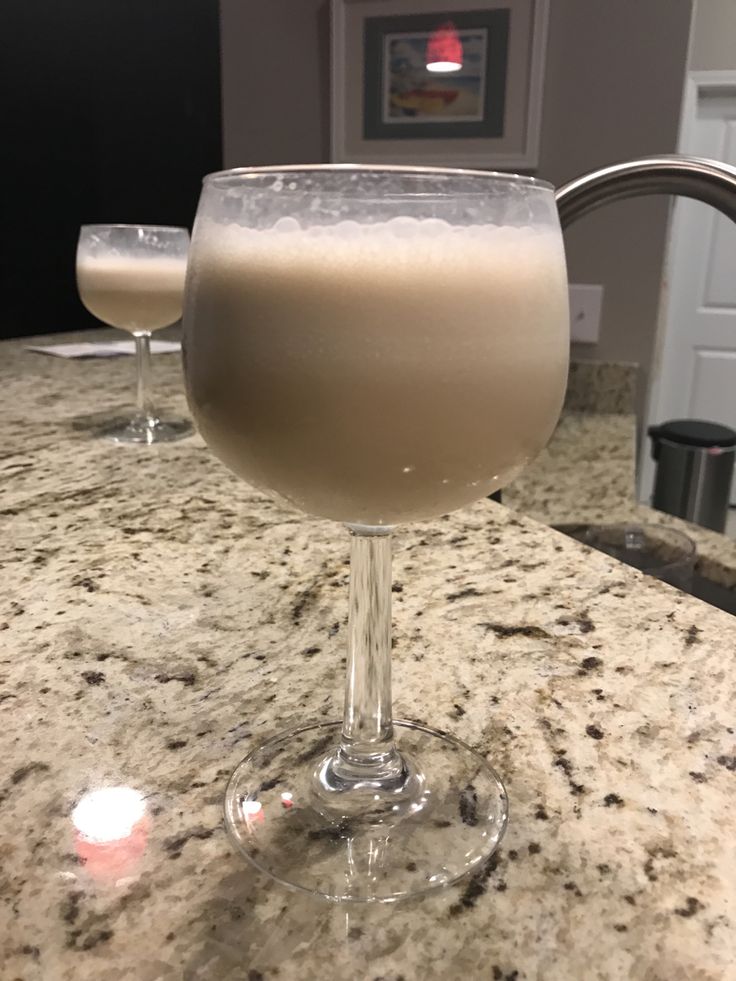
331;0;548;170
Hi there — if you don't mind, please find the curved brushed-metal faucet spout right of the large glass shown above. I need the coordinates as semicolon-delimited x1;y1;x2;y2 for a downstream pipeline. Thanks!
555;154;736;228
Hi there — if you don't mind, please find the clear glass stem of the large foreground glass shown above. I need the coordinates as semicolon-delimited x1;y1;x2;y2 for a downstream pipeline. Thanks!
339;525;399;775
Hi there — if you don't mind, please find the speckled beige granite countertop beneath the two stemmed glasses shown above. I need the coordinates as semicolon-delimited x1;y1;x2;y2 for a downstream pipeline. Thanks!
0;334;736;981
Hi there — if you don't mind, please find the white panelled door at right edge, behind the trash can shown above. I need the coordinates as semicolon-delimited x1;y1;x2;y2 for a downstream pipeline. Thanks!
640;73;736;502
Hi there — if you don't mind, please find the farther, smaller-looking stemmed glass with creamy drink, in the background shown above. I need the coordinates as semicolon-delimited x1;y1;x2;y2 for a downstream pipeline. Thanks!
77;225;193;443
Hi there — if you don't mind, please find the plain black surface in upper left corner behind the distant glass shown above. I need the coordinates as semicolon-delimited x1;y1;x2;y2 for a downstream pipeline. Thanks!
0;0;222;337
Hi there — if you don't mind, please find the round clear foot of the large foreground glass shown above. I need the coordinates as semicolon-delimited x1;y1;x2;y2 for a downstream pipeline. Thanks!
225;722;508;902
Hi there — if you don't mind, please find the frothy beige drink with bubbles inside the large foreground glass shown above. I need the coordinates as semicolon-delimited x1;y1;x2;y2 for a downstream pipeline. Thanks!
185;217;569;525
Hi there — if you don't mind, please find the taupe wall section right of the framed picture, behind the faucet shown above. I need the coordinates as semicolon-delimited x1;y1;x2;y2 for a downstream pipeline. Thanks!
539;0;691;405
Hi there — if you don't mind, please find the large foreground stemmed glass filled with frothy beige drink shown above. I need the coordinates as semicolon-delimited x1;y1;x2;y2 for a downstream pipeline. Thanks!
184;166;569;901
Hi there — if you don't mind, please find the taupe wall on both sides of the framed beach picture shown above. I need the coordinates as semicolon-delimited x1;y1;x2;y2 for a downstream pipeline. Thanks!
221;0;692;406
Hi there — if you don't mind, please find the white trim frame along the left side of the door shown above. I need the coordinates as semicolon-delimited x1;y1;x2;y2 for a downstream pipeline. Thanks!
637;70;736;504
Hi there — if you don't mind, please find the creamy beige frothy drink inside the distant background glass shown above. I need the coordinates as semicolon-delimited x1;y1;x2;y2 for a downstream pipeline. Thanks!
77;255;187;332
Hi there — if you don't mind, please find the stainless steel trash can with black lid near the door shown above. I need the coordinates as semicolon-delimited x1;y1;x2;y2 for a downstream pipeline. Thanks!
649;419;736;531
